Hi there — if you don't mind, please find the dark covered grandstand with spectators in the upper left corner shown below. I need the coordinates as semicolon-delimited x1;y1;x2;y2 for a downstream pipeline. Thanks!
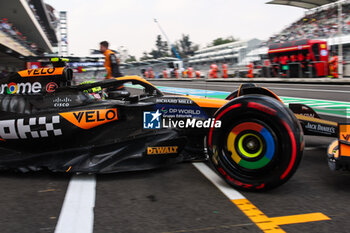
0;0;58;72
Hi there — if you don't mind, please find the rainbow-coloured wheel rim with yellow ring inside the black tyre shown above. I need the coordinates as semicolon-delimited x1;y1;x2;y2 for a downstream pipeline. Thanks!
227;122;276;170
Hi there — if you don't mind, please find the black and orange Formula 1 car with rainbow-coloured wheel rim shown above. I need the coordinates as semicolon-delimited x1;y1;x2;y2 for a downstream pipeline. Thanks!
0;58;339;191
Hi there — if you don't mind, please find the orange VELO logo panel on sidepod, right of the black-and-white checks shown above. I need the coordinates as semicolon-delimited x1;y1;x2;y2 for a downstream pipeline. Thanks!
60;108;118;129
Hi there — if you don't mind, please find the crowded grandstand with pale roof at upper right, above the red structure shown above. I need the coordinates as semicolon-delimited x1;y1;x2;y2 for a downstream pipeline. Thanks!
232;0;350;73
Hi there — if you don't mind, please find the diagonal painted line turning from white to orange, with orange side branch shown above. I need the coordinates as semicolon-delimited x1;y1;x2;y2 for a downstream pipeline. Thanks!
193;163;331;233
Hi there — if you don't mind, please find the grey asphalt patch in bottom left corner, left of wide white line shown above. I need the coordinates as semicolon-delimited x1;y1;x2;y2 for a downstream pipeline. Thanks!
0;171;70;233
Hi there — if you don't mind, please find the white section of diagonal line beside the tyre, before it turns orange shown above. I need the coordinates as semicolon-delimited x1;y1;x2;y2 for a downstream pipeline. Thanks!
192;162;246;200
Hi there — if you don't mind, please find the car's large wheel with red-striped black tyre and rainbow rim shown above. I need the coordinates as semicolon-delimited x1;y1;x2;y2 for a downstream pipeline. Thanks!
207;95;304;191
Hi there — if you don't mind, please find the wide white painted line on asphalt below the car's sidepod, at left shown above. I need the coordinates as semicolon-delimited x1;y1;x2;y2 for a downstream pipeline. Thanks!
55;175;96;233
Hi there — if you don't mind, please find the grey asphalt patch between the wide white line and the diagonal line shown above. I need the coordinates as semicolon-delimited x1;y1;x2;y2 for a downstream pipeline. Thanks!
94;163;260;233
